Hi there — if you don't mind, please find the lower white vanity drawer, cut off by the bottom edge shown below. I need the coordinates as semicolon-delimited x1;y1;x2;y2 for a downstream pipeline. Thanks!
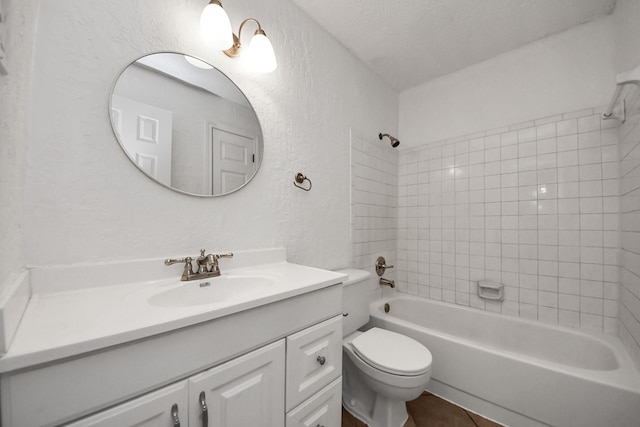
286;377;342;427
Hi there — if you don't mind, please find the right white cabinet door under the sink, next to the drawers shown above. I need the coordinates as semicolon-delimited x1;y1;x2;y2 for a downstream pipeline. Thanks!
189;340;285;427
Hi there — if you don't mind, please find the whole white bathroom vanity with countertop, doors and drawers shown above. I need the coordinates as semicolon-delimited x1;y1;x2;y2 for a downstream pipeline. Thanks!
0;250;344;427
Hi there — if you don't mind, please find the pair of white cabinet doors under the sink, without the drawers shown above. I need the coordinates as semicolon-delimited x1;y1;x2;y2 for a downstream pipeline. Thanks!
65;340;285;427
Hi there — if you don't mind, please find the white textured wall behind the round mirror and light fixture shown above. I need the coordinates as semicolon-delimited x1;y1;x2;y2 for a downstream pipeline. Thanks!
26;0;398;276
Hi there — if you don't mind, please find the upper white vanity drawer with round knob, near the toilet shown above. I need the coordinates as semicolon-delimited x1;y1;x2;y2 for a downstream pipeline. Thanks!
286;315;342;411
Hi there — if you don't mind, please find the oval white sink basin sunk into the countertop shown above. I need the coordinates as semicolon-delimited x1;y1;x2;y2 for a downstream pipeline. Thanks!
148;275;275;307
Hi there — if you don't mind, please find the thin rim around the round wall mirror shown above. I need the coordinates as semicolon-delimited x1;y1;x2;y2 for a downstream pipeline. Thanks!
107;51;264;198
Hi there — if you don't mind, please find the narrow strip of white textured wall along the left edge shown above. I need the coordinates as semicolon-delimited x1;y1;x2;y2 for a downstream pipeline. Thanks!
0;0;37;293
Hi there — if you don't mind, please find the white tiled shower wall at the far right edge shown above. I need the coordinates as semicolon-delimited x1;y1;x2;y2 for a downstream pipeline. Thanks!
619;91;640;368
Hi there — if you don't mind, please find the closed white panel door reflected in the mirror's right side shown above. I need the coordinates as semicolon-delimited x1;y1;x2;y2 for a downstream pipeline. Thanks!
211;127;256;194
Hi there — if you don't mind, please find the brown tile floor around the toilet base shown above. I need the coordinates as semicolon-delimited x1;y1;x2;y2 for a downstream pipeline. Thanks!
342;392;501;427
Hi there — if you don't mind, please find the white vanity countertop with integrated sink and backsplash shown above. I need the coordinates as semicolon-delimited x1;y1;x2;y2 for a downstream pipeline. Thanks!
0;249;346;373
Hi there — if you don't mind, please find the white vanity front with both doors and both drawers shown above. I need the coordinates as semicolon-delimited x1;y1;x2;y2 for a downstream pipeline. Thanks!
66;315;342;427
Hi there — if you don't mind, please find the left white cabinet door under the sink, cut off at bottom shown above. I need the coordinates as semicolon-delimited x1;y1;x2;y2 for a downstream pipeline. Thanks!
66;381;189;427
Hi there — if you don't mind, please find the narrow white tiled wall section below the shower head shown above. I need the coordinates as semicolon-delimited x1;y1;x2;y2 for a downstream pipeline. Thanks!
351;131;398;279
